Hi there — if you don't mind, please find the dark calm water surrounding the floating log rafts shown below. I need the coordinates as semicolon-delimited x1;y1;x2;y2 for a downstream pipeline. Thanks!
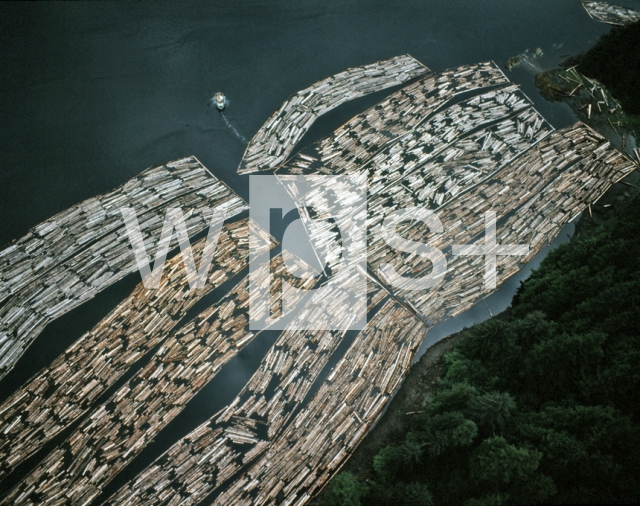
0;0;640;498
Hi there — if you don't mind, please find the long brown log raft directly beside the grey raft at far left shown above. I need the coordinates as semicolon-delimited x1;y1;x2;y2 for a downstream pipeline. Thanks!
0;219;267;477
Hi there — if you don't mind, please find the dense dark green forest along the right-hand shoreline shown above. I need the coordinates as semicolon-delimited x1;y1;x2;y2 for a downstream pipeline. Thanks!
322;24;640;506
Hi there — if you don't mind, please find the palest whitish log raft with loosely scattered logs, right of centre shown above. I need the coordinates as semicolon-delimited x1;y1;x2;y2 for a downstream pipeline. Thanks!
277;86;553;278
